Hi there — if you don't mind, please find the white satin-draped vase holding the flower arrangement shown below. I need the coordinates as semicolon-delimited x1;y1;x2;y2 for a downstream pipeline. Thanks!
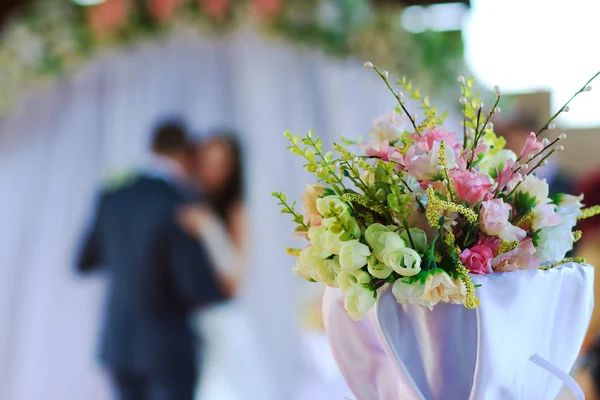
323;263;594;400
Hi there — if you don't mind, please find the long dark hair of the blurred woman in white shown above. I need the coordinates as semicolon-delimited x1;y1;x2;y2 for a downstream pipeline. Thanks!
206;134;244;221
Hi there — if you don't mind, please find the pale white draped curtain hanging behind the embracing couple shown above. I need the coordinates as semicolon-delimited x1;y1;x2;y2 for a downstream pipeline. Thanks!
0;30;452;400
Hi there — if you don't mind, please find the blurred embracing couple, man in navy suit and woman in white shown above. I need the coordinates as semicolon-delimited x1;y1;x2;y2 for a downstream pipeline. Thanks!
78;123;270;400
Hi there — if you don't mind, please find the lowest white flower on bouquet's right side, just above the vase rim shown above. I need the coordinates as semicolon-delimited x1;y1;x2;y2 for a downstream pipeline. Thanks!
533;224;575;264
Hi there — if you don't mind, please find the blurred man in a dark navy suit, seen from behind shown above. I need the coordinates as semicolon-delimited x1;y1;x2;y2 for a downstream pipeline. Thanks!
78;124;225;400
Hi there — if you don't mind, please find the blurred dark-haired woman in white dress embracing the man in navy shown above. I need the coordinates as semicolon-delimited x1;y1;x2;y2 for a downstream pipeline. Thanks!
179;135;270;400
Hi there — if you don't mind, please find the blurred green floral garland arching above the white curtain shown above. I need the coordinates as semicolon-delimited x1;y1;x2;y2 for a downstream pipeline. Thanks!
0;0;462;111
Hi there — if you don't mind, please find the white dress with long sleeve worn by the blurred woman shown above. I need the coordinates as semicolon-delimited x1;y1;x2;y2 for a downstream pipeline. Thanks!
192;214;273;400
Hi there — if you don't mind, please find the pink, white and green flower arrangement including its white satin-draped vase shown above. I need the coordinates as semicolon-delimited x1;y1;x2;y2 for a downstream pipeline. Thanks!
273;62;600;399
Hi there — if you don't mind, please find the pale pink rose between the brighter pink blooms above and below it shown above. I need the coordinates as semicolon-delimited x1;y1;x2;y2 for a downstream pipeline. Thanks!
479;199;527;242
